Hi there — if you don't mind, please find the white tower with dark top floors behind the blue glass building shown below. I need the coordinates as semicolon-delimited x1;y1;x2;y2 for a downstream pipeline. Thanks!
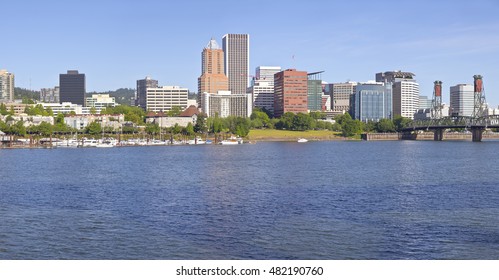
376;71;419;119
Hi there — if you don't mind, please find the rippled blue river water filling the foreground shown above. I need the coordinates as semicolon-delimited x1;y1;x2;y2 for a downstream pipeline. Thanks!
0;141;499;259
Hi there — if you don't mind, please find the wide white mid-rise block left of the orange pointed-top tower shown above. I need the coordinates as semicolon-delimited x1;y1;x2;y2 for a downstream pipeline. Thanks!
146;86;189;112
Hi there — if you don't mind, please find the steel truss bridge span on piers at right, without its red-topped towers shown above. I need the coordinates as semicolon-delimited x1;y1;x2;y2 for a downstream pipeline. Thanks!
401;115;499;142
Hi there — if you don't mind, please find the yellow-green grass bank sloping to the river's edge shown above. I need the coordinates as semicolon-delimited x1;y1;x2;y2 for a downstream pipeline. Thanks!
247;129;344;141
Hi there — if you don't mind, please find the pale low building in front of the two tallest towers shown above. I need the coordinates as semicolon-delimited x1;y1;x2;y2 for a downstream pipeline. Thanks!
201;91;253;118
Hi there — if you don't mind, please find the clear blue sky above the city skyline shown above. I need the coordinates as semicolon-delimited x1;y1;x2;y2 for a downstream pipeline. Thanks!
0;0;499;107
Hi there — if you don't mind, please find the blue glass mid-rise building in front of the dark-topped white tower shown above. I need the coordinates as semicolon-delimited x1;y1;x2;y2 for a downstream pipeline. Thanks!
352;82;393;122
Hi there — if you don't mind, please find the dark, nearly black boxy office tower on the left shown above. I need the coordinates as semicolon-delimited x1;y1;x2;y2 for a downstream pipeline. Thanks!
59;70;85;106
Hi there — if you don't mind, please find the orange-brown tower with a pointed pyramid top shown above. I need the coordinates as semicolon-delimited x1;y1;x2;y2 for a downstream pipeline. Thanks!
198;38;229;94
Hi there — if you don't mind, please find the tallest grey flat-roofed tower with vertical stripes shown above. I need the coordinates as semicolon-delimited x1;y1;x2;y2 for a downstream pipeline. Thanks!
222;34;249;94
